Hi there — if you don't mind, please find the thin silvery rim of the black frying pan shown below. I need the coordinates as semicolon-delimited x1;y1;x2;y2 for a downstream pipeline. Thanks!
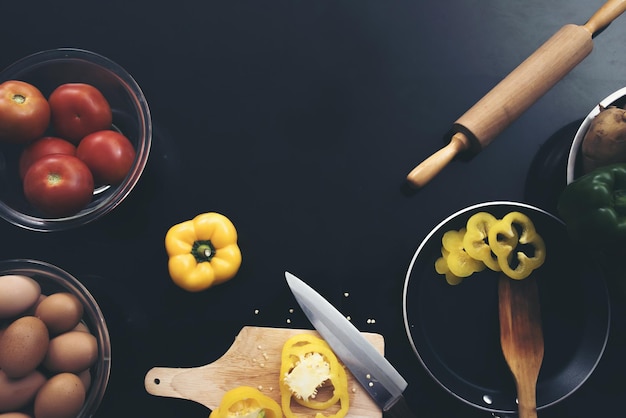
402;200;611;414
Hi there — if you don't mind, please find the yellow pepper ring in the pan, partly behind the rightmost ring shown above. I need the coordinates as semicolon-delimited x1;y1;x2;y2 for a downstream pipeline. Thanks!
463;212;504;271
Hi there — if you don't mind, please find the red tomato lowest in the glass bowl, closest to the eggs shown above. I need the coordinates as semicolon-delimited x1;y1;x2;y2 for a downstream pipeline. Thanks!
24;154;94;217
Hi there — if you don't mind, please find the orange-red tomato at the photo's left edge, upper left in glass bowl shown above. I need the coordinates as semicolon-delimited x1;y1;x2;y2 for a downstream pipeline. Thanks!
0;80;50;144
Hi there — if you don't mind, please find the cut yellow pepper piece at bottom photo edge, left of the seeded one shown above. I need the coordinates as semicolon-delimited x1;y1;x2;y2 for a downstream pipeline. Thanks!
209;386;283;418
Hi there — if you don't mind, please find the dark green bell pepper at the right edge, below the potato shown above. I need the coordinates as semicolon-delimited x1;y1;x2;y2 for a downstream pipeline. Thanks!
557;163;626;249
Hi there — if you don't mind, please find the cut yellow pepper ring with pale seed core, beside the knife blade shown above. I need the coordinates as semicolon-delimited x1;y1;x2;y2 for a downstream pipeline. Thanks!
279;333;350;418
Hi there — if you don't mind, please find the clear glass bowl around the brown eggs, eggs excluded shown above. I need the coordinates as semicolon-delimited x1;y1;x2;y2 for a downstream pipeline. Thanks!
0;259;111;418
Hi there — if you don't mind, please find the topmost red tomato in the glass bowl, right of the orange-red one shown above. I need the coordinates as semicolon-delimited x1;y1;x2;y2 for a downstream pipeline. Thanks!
48;83;113;144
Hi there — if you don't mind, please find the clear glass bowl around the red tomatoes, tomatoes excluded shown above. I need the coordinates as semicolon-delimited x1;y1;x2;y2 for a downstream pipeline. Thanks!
0;48;152;232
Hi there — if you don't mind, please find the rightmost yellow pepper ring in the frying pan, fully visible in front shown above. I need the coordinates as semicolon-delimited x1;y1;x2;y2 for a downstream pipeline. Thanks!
489;212;546;280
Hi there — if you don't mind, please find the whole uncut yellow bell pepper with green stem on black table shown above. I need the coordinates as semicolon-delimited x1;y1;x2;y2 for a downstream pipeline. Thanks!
165;212;241;292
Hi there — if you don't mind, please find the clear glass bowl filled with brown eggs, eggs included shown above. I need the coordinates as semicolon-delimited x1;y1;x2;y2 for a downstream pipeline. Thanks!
0;259;111;418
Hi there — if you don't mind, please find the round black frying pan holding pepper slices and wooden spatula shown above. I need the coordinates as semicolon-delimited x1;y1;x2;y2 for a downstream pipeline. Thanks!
403;202;610;414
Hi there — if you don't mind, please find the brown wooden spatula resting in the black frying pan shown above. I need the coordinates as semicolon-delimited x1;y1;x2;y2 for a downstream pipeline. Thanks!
498;274;543;418
